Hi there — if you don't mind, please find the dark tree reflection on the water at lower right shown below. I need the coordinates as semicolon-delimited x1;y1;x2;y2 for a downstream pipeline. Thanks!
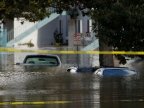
100;78;144;108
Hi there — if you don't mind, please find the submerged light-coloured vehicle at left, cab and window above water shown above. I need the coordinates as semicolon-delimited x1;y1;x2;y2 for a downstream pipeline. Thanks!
17;54;61;71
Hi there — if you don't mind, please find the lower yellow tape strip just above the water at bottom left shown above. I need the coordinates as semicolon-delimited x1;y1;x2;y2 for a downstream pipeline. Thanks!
0;101;72;105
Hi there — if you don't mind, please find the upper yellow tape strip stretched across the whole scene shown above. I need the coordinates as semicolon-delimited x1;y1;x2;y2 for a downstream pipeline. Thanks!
0;47;144;55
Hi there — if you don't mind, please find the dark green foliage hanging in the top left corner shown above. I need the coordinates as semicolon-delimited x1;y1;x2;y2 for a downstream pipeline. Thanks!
0;0;50;21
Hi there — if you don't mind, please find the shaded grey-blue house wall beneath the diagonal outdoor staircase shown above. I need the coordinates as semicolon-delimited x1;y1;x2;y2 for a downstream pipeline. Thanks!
37;15;68;48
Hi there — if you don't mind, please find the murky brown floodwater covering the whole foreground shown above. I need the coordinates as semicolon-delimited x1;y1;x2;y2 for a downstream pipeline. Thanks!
0;52;144;108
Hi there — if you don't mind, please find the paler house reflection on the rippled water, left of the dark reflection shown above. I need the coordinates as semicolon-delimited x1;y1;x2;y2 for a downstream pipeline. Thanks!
0;72;99;108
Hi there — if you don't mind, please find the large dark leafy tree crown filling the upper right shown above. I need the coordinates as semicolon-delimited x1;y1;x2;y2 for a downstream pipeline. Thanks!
92;0;144;63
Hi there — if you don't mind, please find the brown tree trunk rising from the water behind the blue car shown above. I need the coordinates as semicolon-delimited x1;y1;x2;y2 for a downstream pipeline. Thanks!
99;37;114;67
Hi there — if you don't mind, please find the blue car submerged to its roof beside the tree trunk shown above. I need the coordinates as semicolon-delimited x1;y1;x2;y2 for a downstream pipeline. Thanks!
94;67;137;77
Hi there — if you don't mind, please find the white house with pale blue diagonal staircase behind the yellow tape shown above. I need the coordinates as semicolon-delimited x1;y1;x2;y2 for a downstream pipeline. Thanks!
0;9;98;66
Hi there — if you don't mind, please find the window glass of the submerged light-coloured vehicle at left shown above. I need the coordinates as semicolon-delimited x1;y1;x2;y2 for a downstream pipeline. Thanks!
24;56;59;66
